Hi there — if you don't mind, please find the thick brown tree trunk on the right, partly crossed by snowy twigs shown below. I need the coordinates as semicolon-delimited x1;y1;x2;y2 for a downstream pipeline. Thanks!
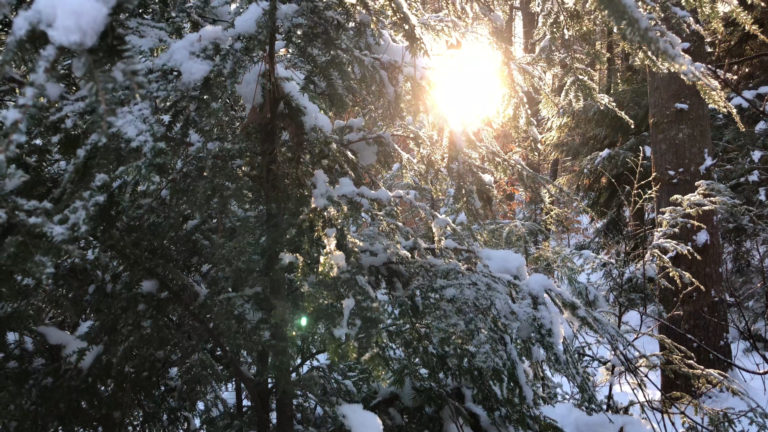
648;72;731;396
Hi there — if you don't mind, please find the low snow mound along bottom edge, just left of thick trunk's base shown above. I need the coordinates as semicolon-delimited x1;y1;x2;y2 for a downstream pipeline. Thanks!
541;403;652;432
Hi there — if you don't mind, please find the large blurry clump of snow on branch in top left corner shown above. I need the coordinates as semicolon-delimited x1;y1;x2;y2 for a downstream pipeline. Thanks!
12;0;114;50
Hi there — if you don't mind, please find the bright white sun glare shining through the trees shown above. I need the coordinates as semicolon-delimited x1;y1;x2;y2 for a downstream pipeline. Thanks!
429;41;506;130
